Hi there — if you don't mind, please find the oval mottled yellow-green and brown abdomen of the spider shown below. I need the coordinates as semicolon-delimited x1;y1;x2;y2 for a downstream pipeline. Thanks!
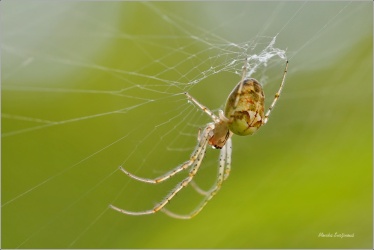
225;78;265;135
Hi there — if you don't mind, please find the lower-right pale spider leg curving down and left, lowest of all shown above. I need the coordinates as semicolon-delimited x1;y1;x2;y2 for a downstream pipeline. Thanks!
162;138;232;219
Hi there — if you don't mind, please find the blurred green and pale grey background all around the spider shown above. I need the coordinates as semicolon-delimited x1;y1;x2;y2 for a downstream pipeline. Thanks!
0;1;373;248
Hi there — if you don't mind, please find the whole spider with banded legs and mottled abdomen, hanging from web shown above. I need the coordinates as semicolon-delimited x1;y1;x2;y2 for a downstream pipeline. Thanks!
110;58;288;219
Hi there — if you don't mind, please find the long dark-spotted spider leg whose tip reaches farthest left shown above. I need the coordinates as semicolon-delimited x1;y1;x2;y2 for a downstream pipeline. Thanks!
109;125;213;215
